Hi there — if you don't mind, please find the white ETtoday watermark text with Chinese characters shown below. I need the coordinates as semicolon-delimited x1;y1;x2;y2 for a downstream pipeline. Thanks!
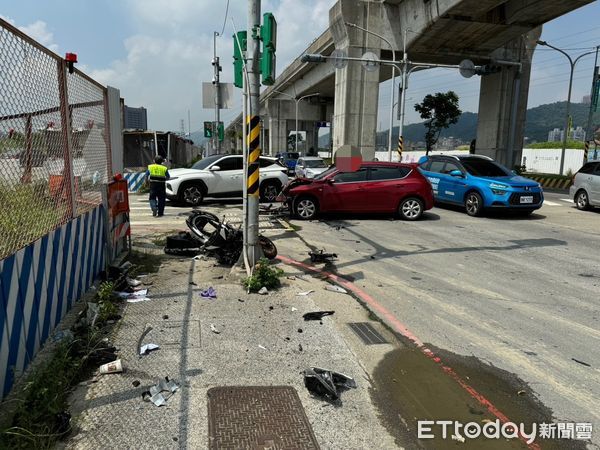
417;419;593;444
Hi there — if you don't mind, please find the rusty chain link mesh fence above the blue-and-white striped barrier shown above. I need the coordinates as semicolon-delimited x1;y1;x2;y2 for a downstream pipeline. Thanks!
0;19;110;259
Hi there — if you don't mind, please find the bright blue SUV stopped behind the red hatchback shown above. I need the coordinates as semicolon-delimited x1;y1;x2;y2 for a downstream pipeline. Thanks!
419;155;544;216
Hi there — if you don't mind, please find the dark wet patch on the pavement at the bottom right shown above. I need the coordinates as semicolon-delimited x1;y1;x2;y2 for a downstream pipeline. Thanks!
371;346;585;450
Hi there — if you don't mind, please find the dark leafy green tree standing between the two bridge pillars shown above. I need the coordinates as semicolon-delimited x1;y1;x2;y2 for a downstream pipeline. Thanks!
415;91;462;155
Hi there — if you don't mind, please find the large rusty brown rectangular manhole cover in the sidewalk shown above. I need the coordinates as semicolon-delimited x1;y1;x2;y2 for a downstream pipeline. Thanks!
207;386;319;450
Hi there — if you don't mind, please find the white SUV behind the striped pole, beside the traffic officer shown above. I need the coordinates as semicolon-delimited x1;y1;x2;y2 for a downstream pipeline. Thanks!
166;155;288;206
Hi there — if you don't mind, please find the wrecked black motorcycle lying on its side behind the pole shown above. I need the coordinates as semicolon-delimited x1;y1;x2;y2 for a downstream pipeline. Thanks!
165;210;277;266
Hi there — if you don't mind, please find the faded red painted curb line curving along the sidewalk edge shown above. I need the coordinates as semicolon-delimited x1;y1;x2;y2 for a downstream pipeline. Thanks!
277;255;541;450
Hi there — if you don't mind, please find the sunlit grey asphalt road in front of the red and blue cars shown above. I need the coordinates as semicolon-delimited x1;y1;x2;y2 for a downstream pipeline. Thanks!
278;193;600;444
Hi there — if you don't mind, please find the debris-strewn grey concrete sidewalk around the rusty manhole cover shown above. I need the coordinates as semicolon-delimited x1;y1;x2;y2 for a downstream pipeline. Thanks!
66;246;397;449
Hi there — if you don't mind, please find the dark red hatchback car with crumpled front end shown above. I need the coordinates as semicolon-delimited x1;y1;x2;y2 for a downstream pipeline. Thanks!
282;162;433;220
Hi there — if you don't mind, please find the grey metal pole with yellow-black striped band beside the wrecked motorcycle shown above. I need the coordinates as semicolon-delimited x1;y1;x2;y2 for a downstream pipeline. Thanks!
245;0;262;267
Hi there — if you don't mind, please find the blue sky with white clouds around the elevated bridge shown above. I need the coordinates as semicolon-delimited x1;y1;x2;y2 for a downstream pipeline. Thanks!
0;0;600;132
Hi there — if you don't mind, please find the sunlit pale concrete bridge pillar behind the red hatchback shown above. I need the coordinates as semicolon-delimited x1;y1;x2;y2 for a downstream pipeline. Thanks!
329;1;382;161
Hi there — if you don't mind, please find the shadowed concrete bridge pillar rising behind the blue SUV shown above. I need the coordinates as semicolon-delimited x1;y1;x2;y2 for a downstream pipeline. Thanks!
475;27;542;169
